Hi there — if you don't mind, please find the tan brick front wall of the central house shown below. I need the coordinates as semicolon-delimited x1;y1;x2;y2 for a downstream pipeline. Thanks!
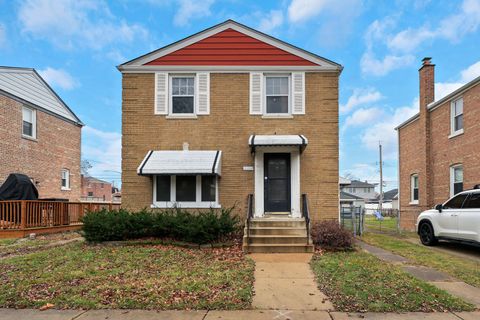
122;73;338;219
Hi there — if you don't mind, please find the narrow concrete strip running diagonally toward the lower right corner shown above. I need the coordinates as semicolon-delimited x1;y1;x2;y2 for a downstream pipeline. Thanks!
357;241;480;308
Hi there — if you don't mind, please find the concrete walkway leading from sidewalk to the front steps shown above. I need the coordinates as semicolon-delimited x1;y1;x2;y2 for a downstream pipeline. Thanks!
250;253;333;310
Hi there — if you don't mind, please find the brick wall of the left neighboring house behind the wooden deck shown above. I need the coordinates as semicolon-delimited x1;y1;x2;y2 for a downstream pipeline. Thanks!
0;94;81;201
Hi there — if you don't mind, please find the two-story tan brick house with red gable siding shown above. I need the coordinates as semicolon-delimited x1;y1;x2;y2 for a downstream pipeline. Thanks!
118;20;342;252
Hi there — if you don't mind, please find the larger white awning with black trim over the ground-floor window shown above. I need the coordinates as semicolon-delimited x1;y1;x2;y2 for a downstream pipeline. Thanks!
137;150;222;175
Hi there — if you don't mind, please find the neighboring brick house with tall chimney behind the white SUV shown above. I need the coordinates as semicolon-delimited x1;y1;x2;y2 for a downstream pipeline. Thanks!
397;58;480;230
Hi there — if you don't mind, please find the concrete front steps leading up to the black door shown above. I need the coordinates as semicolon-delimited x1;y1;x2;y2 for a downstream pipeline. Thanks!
243;217;314;253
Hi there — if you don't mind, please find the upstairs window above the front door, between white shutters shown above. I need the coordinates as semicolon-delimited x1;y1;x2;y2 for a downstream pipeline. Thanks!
265;75;290;114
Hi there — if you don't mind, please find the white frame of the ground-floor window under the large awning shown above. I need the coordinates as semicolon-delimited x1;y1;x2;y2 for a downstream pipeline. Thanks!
151;175;221;209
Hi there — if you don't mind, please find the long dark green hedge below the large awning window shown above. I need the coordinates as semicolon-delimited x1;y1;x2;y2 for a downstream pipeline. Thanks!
82;207;240;244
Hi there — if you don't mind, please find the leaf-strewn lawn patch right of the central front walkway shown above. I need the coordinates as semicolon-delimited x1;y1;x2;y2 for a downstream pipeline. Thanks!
311;251;474;312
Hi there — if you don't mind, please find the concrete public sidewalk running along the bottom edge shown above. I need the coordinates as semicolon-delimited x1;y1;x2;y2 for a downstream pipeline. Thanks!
0;309;480;320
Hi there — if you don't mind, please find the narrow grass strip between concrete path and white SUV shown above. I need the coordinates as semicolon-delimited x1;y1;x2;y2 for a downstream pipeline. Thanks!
361;233;480;287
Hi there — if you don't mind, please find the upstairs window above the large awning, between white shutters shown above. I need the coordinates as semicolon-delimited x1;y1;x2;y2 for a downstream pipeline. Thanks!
170;75;195;115
